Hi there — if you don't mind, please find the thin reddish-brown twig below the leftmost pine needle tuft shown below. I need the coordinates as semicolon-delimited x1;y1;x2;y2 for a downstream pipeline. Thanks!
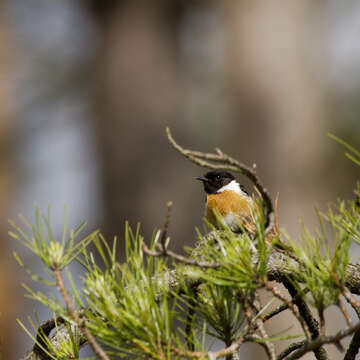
54;268;110;360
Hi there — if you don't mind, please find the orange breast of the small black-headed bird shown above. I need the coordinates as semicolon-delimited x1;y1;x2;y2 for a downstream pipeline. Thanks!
206;190;254;232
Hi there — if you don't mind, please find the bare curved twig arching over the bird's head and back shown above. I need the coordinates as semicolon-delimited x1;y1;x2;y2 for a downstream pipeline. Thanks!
166;128;274;228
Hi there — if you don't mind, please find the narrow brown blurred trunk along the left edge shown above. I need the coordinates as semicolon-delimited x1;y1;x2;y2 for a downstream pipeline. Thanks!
0;3;19;359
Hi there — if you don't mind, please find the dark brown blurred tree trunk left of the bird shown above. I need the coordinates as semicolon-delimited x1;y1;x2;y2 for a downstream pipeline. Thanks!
87;0;193;249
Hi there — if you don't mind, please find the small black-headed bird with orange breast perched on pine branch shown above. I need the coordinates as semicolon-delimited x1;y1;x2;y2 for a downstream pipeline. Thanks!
196;170;256;234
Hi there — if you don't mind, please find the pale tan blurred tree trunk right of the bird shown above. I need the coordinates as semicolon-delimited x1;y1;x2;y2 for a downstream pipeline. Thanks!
221;0;336;359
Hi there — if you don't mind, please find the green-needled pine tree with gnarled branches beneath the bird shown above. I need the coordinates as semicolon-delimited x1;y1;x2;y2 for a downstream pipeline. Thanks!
14;129;360;360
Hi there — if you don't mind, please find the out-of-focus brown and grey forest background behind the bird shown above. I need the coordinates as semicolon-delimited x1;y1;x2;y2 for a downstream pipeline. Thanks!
0;0;360;359
